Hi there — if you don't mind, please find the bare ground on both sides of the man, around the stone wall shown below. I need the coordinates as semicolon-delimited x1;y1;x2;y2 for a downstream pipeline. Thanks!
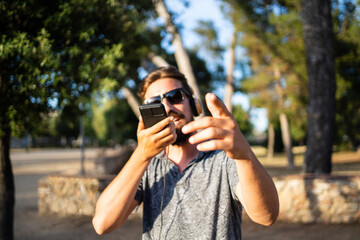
11;149;360;240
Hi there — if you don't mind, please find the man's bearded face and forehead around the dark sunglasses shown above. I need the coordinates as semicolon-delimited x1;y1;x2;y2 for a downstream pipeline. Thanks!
145;78;193;142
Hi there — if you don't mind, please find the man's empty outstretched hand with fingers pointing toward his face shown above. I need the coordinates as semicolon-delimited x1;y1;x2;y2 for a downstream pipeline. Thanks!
182;93;251;159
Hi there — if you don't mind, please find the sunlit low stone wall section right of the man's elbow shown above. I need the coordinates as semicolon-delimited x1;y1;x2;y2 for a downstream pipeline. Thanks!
274;175;360;223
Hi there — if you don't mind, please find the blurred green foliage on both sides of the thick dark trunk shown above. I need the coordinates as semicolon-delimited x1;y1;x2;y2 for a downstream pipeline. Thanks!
223;0;360;148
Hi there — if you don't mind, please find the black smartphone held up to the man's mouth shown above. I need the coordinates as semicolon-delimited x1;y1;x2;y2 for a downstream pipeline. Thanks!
139;103;167;128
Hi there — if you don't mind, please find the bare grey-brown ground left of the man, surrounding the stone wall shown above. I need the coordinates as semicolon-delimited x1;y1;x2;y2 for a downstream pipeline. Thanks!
11;149;142;240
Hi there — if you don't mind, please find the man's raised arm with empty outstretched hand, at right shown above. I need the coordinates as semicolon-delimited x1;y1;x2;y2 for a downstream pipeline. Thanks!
182;94;279;225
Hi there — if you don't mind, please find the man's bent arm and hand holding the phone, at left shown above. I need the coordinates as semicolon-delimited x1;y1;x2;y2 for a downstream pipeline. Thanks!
93;117;176;234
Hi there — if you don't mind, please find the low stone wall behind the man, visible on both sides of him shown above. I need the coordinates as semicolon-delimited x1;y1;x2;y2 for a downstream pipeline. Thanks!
38;175;360;223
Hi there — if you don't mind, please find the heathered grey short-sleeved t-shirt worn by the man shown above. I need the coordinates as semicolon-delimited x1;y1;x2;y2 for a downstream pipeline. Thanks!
135;151;242;240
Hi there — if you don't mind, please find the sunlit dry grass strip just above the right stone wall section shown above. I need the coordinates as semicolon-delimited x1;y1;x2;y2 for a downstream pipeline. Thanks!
252;146;360;177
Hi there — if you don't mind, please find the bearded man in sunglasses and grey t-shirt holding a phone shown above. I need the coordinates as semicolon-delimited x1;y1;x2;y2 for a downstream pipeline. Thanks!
93;67;279;239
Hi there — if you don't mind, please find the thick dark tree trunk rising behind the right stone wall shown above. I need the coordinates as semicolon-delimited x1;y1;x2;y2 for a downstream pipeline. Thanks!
301;0;336;173
